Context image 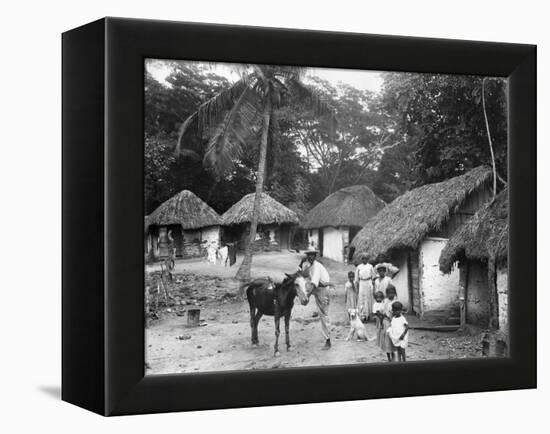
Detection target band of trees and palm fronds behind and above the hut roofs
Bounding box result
[144,61,507,232]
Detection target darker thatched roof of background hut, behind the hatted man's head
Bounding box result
[301,185,385,229]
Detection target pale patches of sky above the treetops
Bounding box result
[146,59,382,92]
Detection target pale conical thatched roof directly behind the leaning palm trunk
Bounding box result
[222,193,298,226]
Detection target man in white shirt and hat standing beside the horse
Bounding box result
[300,250,331,350]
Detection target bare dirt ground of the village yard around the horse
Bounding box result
[145,252,488,375]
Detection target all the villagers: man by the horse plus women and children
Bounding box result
[299,250,409,362]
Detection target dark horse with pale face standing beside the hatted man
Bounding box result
[245,272,308,356]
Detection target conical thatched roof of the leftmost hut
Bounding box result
[149,190,221,230]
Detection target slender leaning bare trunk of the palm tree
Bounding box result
[235,93,272,284]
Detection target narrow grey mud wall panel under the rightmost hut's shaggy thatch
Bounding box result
[466,261,489,327]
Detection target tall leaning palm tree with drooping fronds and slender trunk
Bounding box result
[177,65,336,281]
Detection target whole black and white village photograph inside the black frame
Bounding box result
[143,58,510,375]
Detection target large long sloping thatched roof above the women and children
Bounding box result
[352,166,492,260]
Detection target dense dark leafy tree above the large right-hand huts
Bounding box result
[380,73,507,185]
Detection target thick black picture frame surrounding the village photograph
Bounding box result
[62,18,536,415]
